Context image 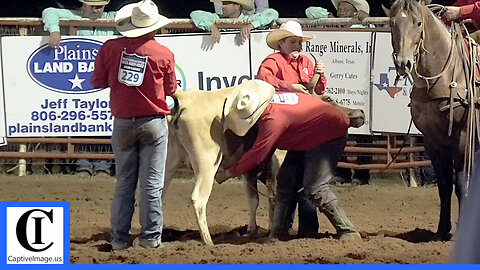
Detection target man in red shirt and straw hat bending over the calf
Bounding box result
[216,89,360,239]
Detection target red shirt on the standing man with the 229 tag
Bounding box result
[90,36,177,118]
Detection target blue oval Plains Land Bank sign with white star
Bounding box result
[27,38,102,94]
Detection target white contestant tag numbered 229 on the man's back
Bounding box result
[118,52,148,86]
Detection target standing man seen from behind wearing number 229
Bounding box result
[91,0,177,250]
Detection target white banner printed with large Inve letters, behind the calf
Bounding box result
[156,33,252,91]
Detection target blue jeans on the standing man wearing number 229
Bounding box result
[110,115,168,249]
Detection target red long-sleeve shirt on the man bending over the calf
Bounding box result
[228,93,350,176]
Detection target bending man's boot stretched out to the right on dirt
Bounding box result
[320,200,362,240]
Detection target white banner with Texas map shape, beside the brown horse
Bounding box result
[371,33,420,134]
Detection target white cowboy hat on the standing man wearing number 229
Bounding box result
[115,0,170,37]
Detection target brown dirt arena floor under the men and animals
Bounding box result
[0,175,457,264]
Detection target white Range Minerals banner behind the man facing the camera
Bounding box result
[251,31,372,134]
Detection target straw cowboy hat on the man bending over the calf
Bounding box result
[223,80,275,136]
